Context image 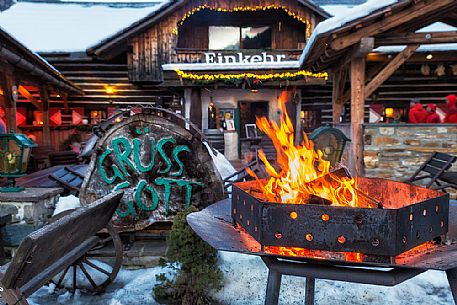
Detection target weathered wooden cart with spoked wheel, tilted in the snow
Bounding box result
[0,192,123,305]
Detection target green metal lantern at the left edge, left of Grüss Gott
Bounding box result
[0,131,37,192]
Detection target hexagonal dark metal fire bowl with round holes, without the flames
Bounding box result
[231,178,449,257]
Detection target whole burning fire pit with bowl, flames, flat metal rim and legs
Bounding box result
[187,101,457,305]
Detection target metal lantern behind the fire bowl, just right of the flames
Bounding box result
[309,125,351,166]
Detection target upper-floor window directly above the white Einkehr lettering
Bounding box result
[209,26,272,50]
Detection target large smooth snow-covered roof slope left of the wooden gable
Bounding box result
[0,0,164,52]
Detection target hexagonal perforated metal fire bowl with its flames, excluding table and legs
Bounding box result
[231,100,449,262]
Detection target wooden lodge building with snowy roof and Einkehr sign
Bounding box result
[0,0,457,178]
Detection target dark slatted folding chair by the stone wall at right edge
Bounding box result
[408,152,457,189]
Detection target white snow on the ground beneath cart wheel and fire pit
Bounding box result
[29,252,453,305]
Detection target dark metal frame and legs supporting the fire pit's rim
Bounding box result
[262,257,430,305]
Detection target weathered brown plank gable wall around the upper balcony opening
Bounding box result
[128,0,319,82]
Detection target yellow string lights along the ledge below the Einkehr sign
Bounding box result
[175,69,328,81]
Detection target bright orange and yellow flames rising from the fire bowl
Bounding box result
[248,92,359,207]
